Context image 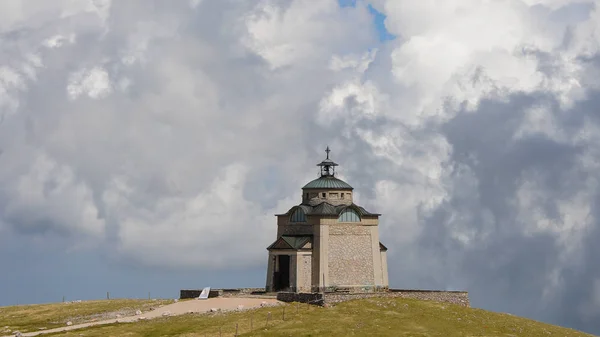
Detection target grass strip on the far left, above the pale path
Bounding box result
[0,299,173,336]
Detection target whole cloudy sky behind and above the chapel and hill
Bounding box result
[0,0,600,334]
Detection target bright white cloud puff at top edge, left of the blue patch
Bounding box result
[244,0,370,69]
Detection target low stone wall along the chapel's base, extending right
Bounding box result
[277,289,471,307]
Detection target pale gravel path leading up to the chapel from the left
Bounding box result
[2,297,282,337]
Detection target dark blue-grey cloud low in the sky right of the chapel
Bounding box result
[432,92,600,333]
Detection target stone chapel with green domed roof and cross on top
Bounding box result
[266,147,389,293]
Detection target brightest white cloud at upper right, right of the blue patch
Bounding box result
[372,0,593,125]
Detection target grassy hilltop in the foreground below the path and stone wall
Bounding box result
[29,298,591,337]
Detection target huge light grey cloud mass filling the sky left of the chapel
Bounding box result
[0,1,375,268]
